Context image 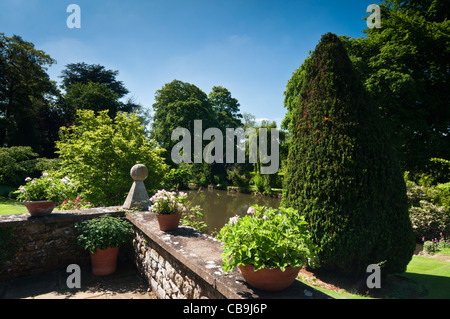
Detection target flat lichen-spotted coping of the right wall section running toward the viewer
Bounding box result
[126,212,329,299]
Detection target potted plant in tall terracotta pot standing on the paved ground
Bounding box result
[75,215,133,276]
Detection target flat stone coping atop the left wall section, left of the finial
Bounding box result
[0,206,125,227]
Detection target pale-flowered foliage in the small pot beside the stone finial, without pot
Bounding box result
[148,189,187,215]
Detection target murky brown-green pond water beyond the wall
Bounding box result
[186,189,281,232]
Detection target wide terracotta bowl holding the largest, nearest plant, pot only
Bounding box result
[238,265,301,291]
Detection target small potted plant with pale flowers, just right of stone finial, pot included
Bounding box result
[148,189,187,231]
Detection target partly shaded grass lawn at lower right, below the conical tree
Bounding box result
[299,255,450,299]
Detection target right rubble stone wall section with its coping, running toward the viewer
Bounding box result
[127,212,327,299]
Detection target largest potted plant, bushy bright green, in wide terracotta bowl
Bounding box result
[218,206,317,291]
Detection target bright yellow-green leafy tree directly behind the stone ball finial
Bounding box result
[57,110,167,205]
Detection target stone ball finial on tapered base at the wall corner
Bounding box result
[123,164,150,210]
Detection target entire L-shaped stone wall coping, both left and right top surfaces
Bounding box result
[0,206,329,299]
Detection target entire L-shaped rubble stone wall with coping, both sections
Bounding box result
[0,207,327,299]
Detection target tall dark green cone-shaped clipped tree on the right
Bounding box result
[282,33,415,276]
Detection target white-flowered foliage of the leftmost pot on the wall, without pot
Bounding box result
[15,173,75,203]
